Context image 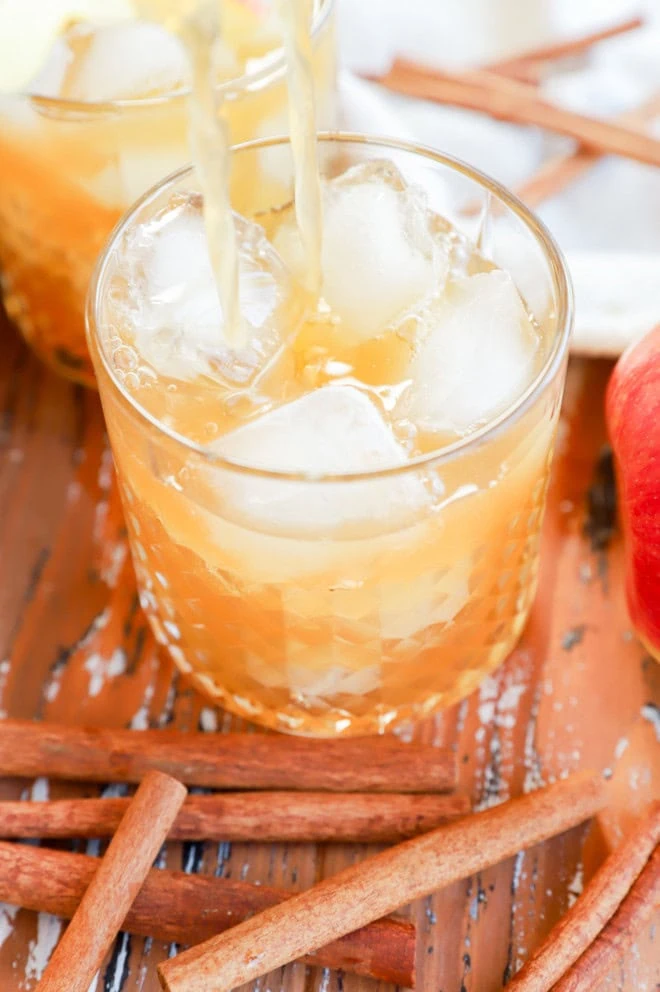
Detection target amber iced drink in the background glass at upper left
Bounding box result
[0,0,335,385]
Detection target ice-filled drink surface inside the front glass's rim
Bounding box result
[106,160,544,456]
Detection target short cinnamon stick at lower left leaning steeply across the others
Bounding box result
[37,772,186,992]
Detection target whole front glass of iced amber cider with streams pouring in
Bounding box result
[90,0,567,735]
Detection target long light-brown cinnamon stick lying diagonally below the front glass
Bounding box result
[158,774,605,992]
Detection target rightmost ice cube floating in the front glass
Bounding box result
[398,270,538,435]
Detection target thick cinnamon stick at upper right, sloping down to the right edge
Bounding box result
[369,59,660,165]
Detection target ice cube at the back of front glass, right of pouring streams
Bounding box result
[275,161,448,344]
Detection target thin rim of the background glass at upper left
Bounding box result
[20,0,336,113]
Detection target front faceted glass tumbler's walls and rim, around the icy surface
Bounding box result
[88,133,572,736]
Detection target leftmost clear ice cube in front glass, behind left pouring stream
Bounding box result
[121,200,299,386]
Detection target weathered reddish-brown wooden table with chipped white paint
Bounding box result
[0,306,660,992]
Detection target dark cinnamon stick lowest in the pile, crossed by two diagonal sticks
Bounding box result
[0,841,415,988]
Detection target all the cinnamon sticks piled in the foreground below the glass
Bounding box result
[0,721,660,992]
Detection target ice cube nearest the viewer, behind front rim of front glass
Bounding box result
[214,385,426,536]
